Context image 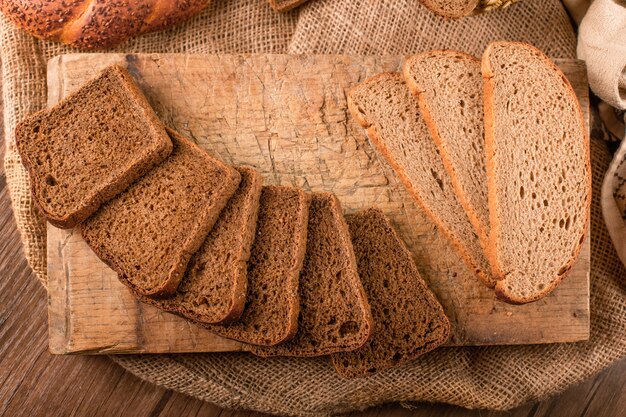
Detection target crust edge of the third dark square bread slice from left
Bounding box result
[128,167,263,324]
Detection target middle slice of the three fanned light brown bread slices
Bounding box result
[403,51,489,248]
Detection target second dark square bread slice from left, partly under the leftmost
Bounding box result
[82,130,240,297]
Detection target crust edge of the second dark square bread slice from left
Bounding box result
[81,128,240,299]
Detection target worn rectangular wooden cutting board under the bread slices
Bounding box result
[48,54,590,354]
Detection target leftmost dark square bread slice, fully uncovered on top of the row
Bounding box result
[15,66,172,228]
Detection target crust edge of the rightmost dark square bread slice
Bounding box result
[331,207,451,378]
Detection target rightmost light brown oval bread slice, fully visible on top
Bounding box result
[482,42,591,303]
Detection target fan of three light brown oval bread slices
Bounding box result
[348,42,591,304]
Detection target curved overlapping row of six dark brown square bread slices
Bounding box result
[16,66,450,377]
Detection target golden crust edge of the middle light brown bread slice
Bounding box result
[402,49,489,251]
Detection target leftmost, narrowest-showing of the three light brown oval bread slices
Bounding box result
[348,73,495,287]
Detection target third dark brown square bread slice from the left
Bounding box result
[139,167,263,324]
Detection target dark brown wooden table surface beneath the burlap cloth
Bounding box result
[0,74,626,417]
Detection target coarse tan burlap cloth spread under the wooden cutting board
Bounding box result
[0,0,626,415]
